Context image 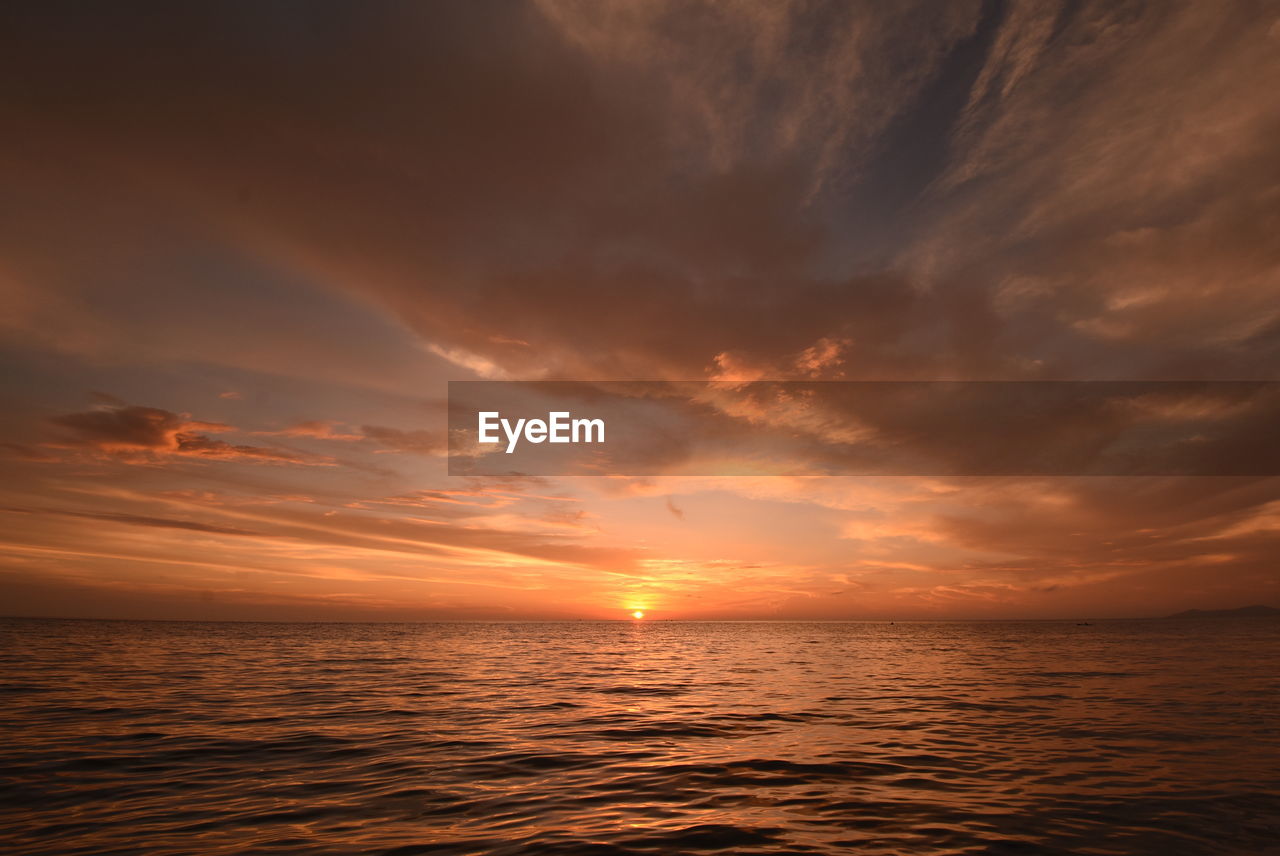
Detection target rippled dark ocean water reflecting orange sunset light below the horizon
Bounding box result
[0,621,1280,855]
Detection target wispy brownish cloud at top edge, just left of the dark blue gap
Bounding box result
[529,0,979,187]
